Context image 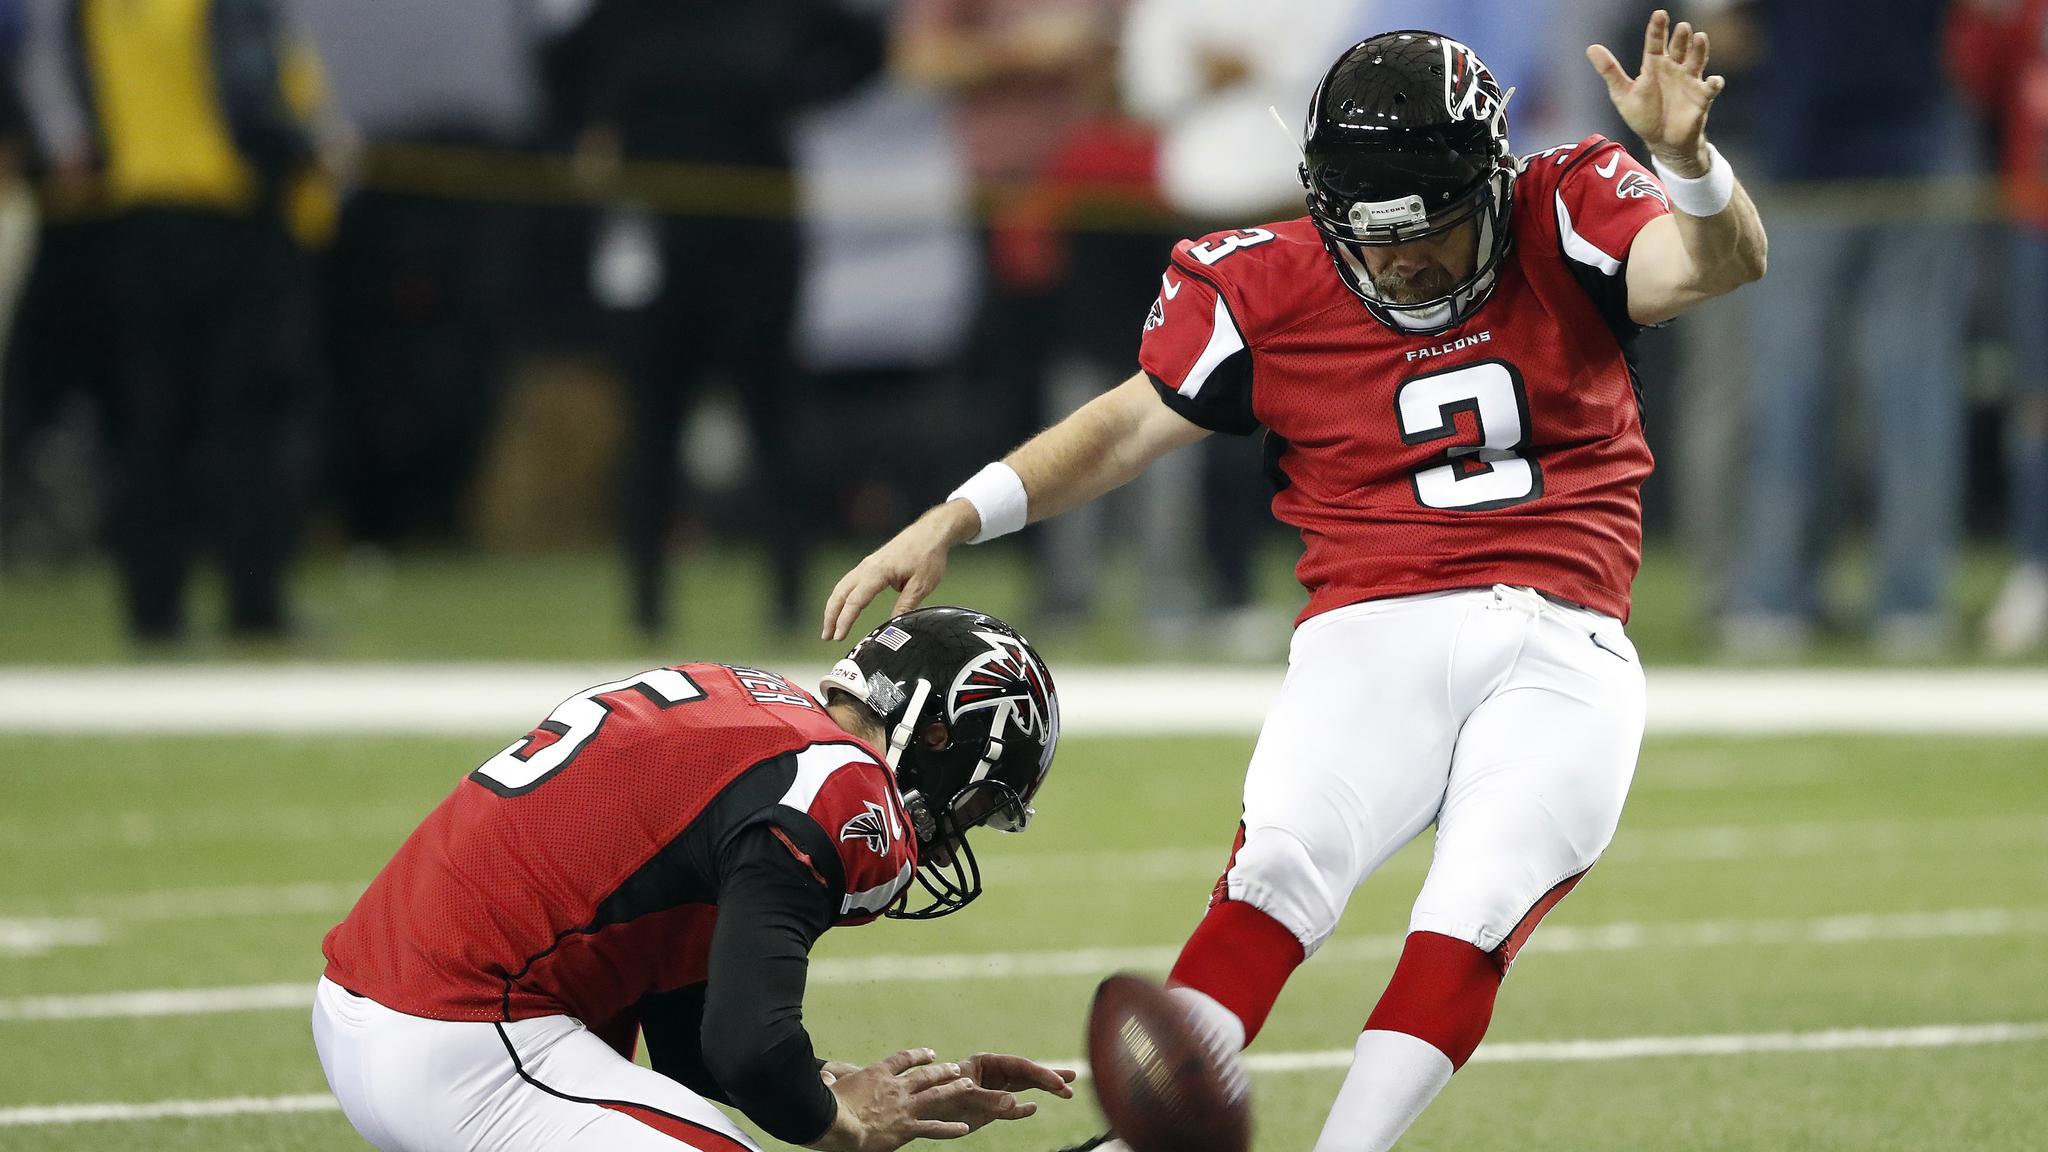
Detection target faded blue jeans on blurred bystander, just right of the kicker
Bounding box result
[1729,215,1970,623]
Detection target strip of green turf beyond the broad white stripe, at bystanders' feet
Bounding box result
[0,535,2048,668]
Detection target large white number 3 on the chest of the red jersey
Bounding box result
[1395,361,1542,512]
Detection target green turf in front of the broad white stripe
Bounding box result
[0,736,2048,1152]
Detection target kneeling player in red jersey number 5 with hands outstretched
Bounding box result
[313,609,1073,1152]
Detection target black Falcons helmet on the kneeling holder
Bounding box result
[819,607,1059,920]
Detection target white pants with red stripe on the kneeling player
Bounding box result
[313,978,760,1152]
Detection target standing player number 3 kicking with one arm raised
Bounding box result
[825,12,1765,1152]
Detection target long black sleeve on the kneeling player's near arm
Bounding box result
[696,824,838,1144]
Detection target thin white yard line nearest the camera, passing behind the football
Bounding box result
[16,1023,2048,1127]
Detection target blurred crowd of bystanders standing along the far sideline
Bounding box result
[0,0,2048,660]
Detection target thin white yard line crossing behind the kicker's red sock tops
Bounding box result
[0,908,2048,1021]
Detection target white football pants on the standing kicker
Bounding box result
[1225,584,1642,955]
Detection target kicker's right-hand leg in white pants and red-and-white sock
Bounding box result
[1317,605,1645,1152]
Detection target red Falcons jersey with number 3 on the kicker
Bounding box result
[1139,135,1669,619]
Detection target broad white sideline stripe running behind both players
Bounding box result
[0,664,2048,738]
